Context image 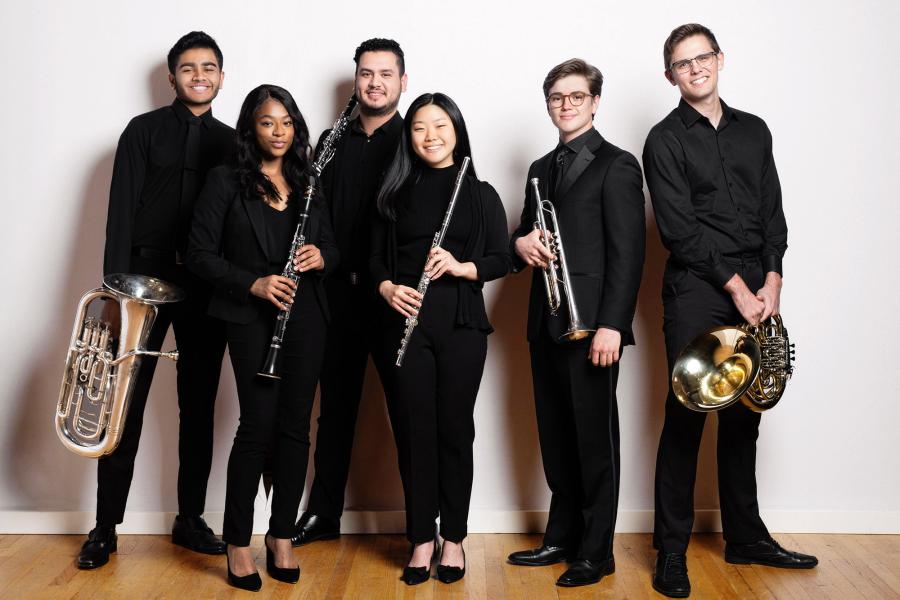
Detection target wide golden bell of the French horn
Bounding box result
[672,327,761,412]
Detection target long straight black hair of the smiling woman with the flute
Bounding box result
[377,92,476,221]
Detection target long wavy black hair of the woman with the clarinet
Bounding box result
[235,84,312,204]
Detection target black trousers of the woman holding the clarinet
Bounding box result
[222,283,326,546]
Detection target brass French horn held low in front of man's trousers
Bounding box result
[672,315,794,412]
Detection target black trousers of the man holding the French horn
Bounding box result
[653,259,769,553]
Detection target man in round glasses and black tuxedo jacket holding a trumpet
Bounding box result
[509,59,644,586]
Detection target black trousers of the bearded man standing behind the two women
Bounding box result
[306,275,379,519]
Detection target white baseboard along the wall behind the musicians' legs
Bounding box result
[0,506,900,535]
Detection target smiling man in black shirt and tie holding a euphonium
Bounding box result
[77,31,234,569]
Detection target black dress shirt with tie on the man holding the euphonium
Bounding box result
[103,100,234,274]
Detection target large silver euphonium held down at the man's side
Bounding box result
[56,274,184,458]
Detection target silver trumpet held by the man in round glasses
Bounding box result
[531,177,596,342]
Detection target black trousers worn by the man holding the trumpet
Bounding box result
[530,330,620,561]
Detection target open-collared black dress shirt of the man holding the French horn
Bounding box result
[644,99,787,287]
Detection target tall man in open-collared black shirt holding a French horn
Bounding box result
[644,23,817,598]
